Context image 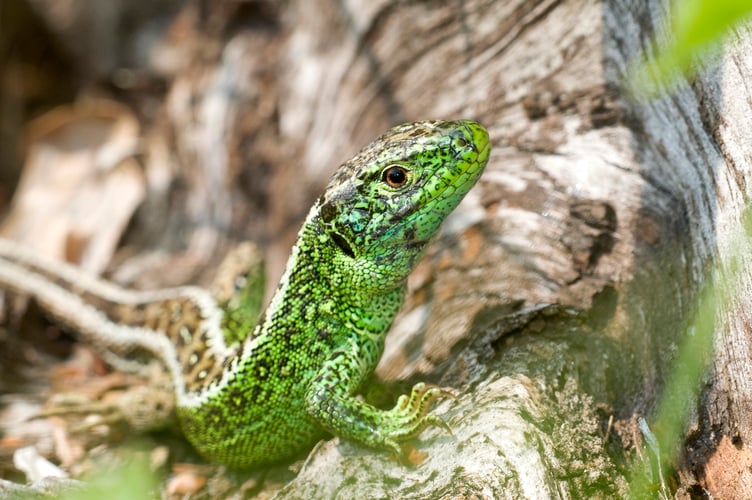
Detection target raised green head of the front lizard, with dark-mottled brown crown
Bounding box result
[319,120,490,290]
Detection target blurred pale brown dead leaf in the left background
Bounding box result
[0,100,145,272]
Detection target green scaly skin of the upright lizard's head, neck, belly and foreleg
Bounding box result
[178,121,490,467]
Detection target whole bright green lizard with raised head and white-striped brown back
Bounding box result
[0,121,490,468]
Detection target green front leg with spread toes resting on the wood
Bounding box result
[305,339,452,456]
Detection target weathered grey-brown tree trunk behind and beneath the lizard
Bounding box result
[1,0,752,498]
